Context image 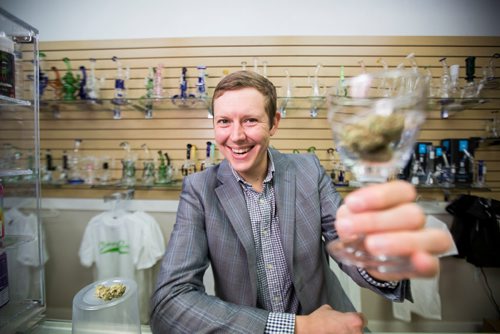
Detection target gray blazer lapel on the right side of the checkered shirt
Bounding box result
[271,150,297,273]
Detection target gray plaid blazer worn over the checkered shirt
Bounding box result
[151,149,409,334]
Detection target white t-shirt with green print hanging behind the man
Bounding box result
[79,211,165,323]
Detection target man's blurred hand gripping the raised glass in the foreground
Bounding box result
[336,181,451,281]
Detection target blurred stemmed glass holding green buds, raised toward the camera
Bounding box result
[328,69,430,272]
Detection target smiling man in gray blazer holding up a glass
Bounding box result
[151,71,450,334]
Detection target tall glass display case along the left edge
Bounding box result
[0,8,46,334]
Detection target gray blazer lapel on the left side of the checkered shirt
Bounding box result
[215,160,257,302]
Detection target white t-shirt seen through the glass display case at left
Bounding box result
[5,208,49,301]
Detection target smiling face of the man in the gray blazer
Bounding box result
[214,88,280,183]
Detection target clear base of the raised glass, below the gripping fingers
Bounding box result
[328,237,413,273]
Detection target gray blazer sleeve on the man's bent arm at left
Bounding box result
[150,173,269,333]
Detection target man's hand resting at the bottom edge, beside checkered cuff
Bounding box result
[295,305,366,334]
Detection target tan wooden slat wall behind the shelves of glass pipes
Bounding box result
[9,36,500,199]
